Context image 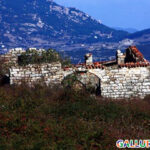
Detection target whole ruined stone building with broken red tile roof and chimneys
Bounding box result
[0,46,150,99]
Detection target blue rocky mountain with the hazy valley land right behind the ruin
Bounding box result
[0,0,149,63]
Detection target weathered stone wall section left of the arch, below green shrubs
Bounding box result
[10,62,64,85]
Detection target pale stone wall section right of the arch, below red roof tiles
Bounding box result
[89,67,150,98]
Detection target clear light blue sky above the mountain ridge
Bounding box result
[54,0,150,30]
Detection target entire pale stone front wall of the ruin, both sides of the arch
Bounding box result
[10,63,150,98]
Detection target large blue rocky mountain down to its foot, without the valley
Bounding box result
[0,0,127,47]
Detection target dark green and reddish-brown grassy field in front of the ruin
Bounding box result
[0,86,150,150]
